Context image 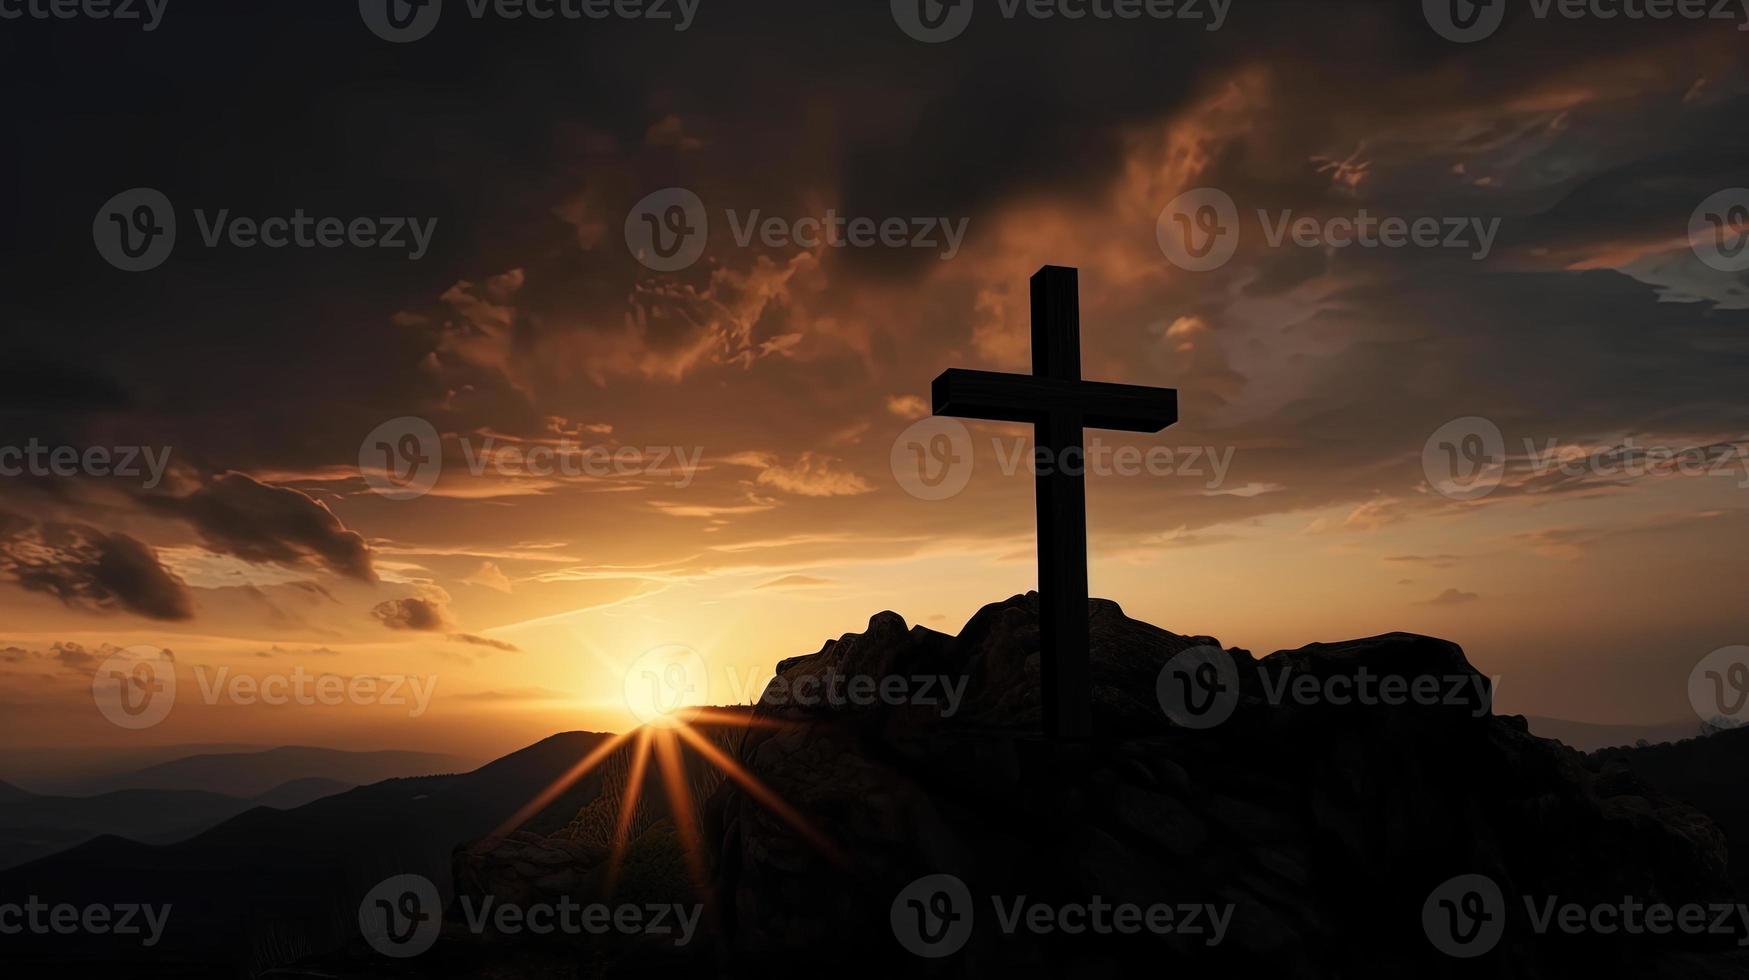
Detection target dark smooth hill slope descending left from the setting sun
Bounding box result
[0,733,607,977]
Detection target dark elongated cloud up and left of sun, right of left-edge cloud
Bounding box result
[145,473,376,583]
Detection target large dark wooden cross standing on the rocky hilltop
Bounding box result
[932,266,1179,739]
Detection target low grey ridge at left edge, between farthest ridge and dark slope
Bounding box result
[0,779,352,868]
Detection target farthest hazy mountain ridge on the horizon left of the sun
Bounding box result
[87,746,474,798]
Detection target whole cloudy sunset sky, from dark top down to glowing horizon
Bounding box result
[0,0,1749,758]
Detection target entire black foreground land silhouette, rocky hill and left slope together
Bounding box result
[0,595,1749,978]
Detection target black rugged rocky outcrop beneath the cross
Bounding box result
[708,595,1742,978]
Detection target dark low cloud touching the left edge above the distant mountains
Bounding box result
[0,511,194,621]
